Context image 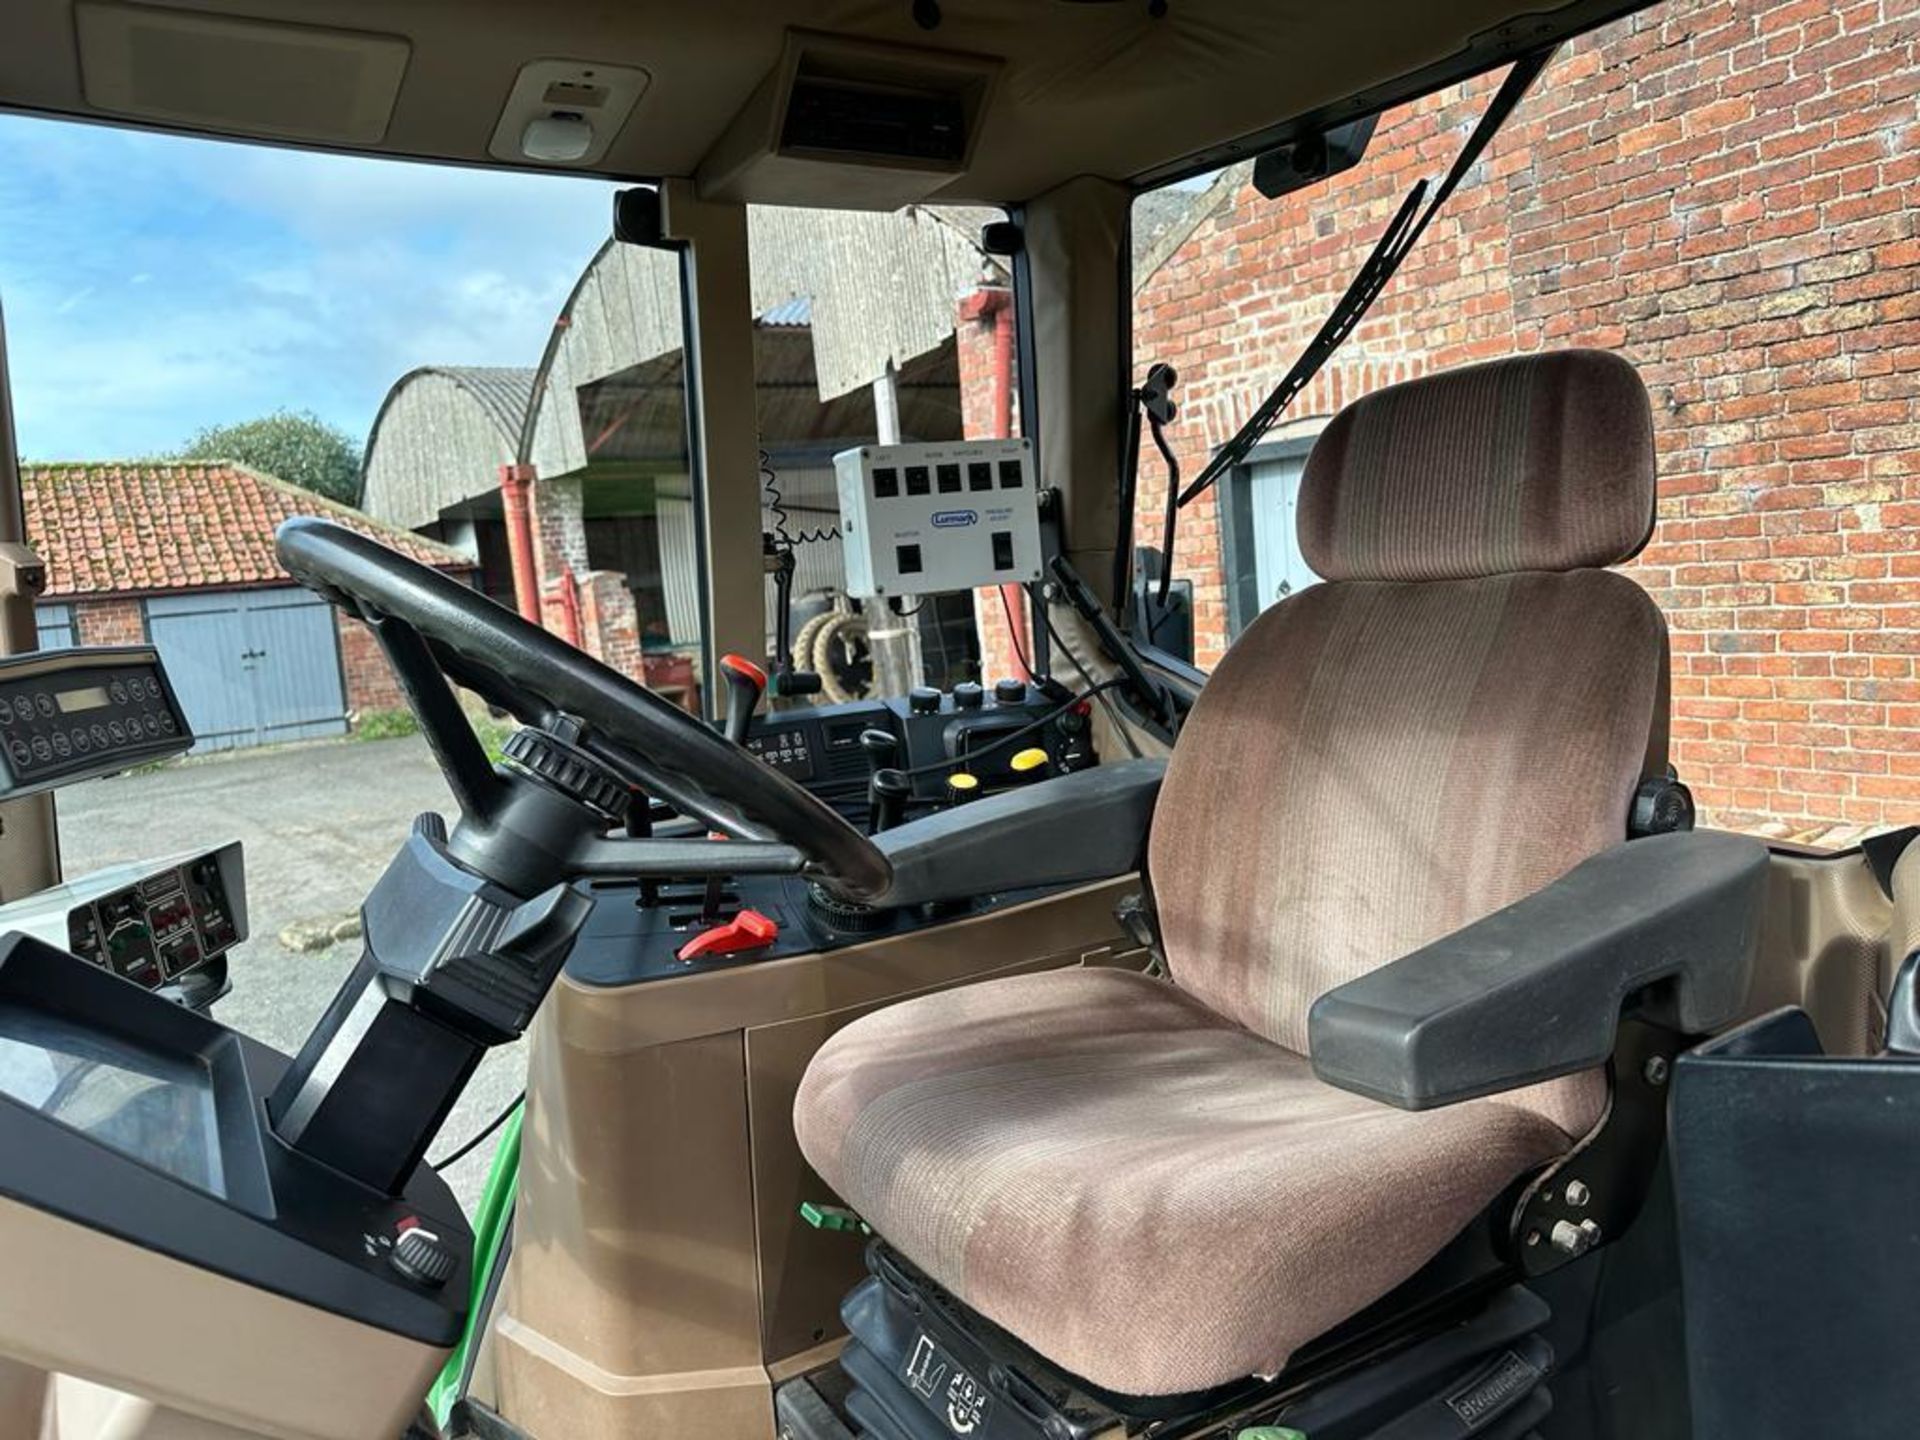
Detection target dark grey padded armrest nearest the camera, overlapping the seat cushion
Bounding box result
[1308,829,1766,1110]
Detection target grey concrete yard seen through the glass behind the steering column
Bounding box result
[58,737,526,1212]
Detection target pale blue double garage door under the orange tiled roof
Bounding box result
[146,588,348,751]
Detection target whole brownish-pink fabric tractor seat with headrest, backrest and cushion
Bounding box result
[795,351,1697,1396]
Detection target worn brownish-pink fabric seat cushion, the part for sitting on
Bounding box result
[795,970,1601,1396]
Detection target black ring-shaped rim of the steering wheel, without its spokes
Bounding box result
[275,516,893,900]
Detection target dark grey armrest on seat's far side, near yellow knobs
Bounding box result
[874,760,1167,904]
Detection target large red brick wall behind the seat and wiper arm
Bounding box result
[1135,0,1920,829]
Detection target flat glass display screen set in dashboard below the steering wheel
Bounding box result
[0,1000,227,1196]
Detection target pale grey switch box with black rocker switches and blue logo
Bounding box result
[833,440,1043,599]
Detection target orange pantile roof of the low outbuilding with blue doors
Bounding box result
[21,461,472,599]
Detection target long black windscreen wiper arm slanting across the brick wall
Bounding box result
[1169,46,1557,510]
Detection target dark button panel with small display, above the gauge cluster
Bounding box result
[0,645,194,799]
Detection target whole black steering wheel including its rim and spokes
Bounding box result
[275,516,893,900]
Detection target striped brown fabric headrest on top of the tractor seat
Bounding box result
[1300,349,1655,580]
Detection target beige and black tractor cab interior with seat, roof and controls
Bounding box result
[0,0,1920,1440]
